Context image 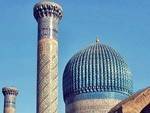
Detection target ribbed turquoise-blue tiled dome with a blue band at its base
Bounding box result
[63,42,132,104]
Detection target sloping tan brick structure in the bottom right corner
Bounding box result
[108,87,150,113]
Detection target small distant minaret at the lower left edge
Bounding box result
[2,87,18,113]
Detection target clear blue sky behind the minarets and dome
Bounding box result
[0,0,150,113]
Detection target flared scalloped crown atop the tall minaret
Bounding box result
[34,0,63,20]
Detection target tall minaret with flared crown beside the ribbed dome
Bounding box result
[34,0,63,113]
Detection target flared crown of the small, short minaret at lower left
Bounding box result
[2,87,18,96]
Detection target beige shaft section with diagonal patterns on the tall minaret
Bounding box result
[37,38,58,113]
